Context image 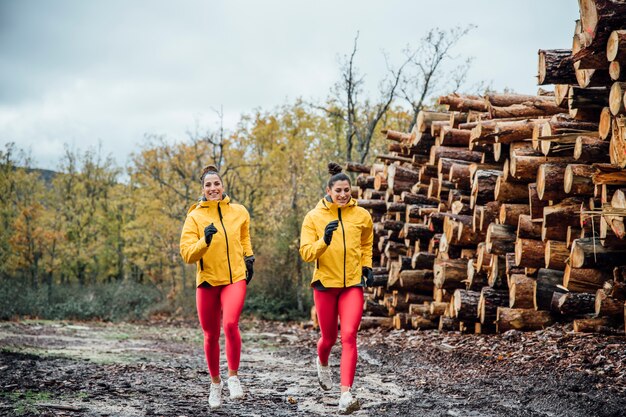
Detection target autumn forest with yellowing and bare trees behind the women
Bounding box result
[0,26,487,320]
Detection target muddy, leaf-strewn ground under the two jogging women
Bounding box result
[0,320,626,417]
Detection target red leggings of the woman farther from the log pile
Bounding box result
[196,280,246,377]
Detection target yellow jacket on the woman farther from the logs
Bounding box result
[180,196,253,286]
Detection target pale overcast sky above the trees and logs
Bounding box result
[0,0,578,169]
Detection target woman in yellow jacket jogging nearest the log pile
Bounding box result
[300,162,374,414]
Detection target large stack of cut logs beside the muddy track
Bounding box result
[347,0,626,333]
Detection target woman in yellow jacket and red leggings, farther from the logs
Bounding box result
[180,165,254,408]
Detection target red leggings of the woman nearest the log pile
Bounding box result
[313,287,363,387]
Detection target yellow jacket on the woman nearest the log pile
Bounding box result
[300,198,374,288]
